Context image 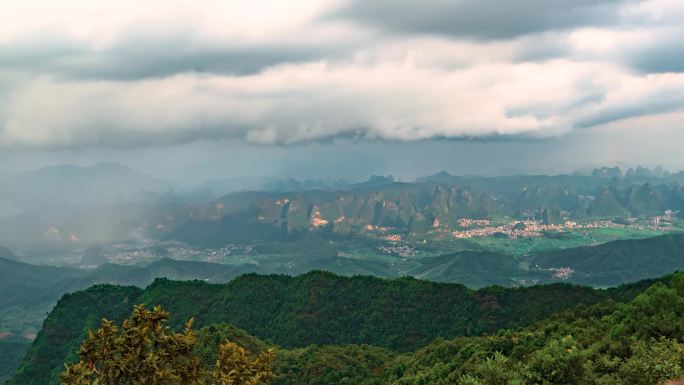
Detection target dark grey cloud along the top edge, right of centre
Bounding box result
[336,0,623,39]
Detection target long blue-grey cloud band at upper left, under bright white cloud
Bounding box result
[0,37,327,80]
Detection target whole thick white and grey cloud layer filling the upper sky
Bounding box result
[0,0,684,148]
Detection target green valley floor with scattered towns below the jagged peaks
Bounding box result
[156,222,683,277]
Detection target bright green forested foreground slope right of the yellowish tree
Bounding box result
[67,273,684,385]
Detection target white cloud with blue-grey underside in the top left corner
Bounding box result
[0,0,364,80]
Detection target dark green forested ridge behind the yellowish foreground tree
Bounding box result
[9,272,670,385]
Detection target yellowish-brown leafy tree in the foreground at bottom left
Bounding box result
[61,305,274,385]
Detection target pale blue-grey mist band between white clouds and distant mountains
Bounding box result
[0,121,684,185]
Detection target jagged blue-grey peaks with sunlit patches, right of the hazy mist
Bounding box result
[164,177,684,244]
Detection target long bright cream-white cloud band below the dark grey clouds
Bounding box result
[5,60,684,147]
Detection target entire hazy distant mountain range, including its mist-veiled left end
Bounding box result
[0,163,684,249]
